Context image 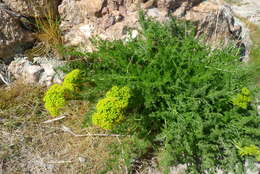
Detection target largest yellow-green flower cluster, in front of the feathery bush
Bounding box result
[92,86,131,130]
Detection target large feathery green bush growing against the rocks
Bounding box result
[64,11,260,173]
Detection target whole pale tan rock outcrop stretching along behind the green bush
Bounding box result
[59,0,249,59]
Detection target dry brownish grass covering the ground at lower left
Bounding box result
[0,83,117,174]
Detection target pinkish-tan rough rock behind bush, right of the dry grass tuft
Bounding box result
[59,0,173,51]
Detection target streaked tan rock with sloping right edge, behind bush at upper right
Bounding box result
[183,0,251,61]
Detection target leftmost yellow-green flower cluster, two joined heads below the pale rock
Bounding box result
[43,69,80,116]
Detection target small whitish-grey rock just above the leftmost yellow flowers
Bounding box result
[8,57,65,86]
